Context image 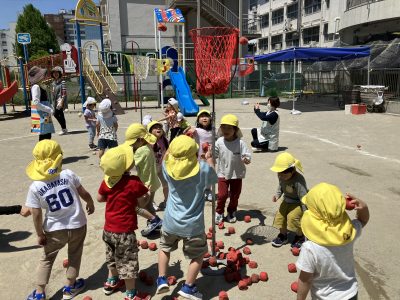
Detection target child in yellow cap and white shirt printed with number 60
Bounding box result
[26,140,94,300]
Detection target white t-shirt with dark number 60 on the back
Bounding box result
[25,169,87,232]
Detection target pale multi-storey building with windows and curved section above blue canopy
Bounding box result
[249,0,400,54]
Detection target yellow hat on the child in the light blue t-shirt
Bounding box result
[165,135,200,180]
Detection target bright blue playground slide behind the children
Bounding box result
[168,67,199,116]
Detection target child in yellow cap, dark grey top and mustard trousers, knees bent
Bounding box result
[271,152,307,248]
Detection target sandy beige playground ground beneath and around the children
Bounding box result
[0,98,400,300]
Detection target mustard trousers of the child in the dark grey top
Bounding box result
[273,201,303,235]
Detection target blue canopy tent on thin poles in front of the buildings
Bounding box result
[254,46,371,114]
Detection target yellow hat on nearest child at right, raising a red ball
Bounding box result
[301,182,356,246]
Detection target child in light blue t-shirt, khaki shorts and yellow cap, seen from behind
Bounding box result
[157,135,217,300]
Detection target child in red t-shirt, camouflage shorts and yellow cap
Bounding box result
[97,145,148,300]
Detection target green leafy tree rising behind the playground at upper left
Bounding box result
[15,4,60,58]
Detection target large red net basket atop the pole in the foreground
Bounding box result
[190,27,239,96]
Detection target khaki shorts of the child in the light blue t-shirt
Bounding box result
[160,229,208,259]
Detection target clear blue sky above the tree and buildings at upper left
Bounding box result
[0,0,99,29]
